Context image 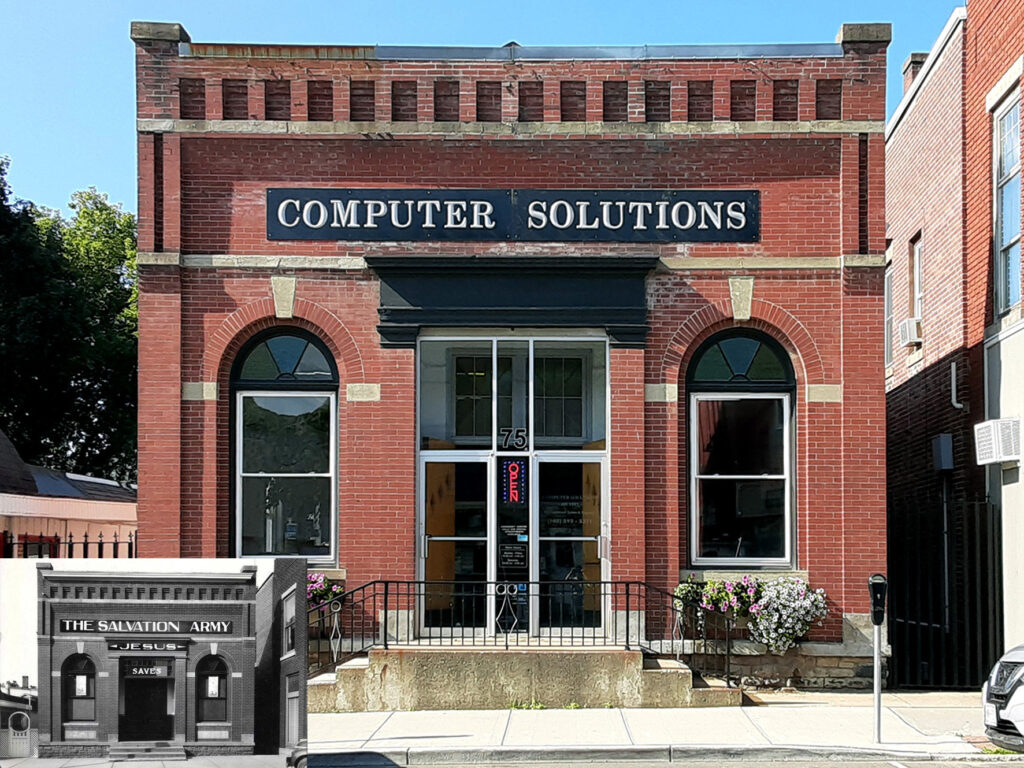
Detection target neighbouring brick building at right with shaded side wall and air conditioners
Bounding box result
[886,0,1024,688]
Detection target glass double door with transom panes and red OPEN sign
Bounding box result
[420,339,606,634]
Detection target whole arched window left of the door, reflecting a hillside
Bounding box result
[231,328,338,561]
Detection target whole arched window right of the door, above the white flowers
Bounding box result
[686,329,796,566]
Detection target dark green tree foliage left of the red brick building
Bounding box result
[0,158,138,479]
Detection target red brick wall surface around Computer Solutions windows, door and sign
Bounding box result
[133,25,888,640]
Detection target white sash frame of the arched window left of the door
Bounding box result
[234,387,338,564]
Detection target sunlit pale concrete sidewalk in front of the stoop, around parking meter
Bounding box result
[309,692,999,765]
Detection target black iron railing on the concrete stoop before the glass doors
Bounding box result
[308,581,734,681]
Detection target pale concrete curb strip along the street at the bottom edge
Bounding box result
[309,744,995,768]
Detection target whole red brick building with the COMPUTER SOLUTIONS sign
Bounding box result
[132,23,890,671]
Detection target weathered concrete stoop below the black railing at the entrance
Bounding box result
[307,648,742,713]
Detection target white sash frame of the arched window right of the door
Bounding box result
[688,390,795,567]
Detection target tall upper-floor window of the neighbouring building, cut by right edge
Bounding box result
[993,95,1021,312]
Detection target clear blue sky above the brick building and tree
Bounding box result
[0,0,963,217]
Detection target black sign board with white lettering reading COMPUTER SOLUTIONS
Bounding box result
[266,188,761,243]
